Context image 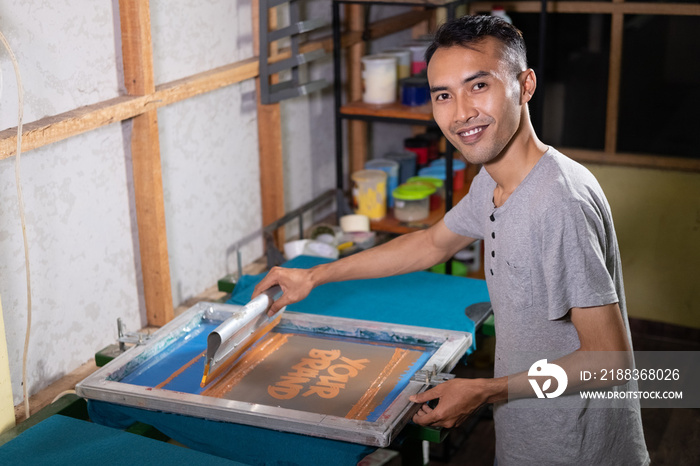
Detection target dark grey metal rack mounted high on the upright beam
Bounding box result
[259,0,328,104]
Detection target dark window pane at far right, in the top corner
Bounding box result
[617,15,700,158]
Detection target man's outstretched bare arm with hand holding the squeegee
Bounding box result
[253,220,474,315]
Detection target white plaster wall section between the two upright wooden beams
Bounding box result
[151,0,262,305]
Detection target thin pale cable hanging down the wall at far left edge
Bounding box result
[0,27,32,418]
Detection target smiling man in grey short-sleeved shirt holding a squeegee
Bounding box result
[254,16,649,465]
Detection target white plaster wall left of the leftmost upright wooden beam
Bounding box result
[0,0,132,403]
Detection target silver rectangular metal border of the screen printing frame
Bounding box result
[76,302,472,447]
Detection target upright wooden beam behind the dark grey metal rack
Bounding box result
[251,0,285,249]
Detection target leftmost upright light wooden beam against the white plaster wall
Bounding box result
[119,0,174,326]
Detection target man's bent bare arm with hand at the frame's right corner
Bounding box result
[411,303,630,427]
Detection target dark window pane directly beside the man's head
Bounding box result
[509,13,610,150]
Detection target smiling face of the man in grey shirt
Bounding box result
[428,37,522,164]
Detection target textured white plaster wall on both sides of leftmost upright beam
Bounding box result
[0,0,266,403]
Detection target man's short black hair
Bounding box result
[425,15,527,73]
